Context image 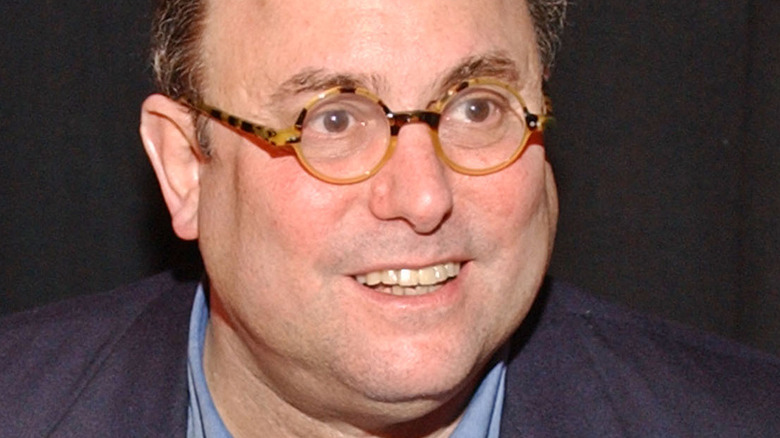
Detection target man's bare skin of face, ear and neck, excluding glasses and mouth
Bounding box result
[141,0,557,437]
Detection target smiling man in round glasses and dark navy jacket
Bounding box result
[0,0,780,437]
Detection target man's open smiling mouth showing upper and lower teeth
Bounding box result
[355,262,460,296]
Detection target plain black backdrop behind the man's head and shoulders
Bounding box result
[0,0,780,353]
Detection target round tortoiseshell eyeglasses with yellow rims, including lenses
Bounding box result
[185,78,552,184]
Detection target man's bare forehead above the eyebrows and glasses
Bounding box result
[203,0,541,105]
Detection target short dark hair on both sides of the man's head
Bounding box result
[152,0,568,100]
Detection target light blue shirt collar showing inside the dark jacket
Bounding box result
[187,285,506,438]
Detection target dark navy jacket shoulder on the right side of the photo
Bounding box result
[505,281,780,436]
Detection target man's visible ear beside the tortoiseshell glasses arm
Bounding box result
[140,94,204,240]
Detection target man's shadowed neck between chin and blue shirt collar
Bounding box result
[203,312,478,438]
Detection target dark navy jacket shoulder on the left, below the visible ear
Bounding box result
[0,273,195,436]
